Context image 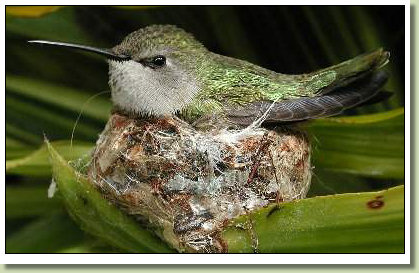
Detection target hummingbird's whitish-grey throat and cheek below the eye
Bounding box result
[109,60,199,116]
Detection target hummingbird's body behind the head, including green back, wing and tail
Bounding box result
[185,49,389,123]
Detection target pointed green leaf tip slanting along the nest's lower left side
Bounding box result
[47,142,173,253]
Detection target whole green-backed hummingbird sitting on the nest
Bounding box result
[29,25,390,125]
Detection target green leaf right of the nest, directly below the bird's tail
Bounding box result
[308,108,404,179]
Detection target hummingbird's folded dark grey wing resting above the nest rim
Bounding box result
[227,71,388,125]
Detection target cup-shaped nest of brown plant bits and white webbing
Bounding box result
[88,113,311,253]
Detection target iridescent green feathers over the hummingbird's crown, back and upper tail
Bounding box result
[113,25,389,122]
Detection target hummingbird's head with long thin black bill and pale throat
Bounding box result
[31,25,207,116]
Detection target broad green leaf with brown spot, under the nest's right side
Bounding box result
[222,186,404,253]
